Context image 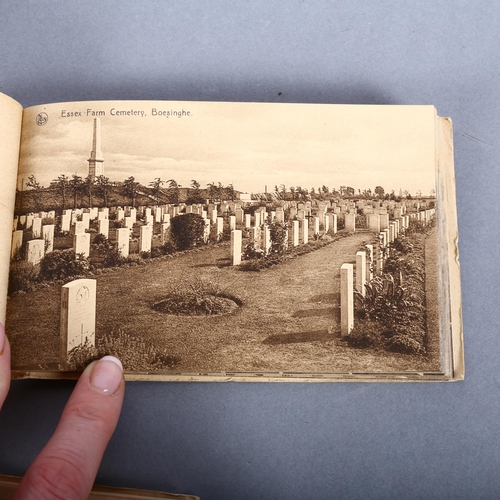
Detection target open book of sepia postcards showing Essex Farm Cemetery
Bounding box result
[0,96,464,381]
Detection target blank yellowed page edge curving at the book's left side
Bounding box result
[0,94,23,323]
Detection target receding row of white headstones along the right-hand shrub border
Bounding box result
[340,209,436,336]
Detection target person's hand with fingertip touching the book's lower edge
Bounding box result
[0,322,125,500]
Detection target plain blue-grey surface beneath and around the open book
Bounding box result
[0,0,494,500]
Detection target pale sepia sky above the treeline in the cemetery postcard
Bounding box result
[19,101,435,195]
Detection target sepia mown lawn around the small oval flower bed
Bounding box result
[7,232,440,373]
